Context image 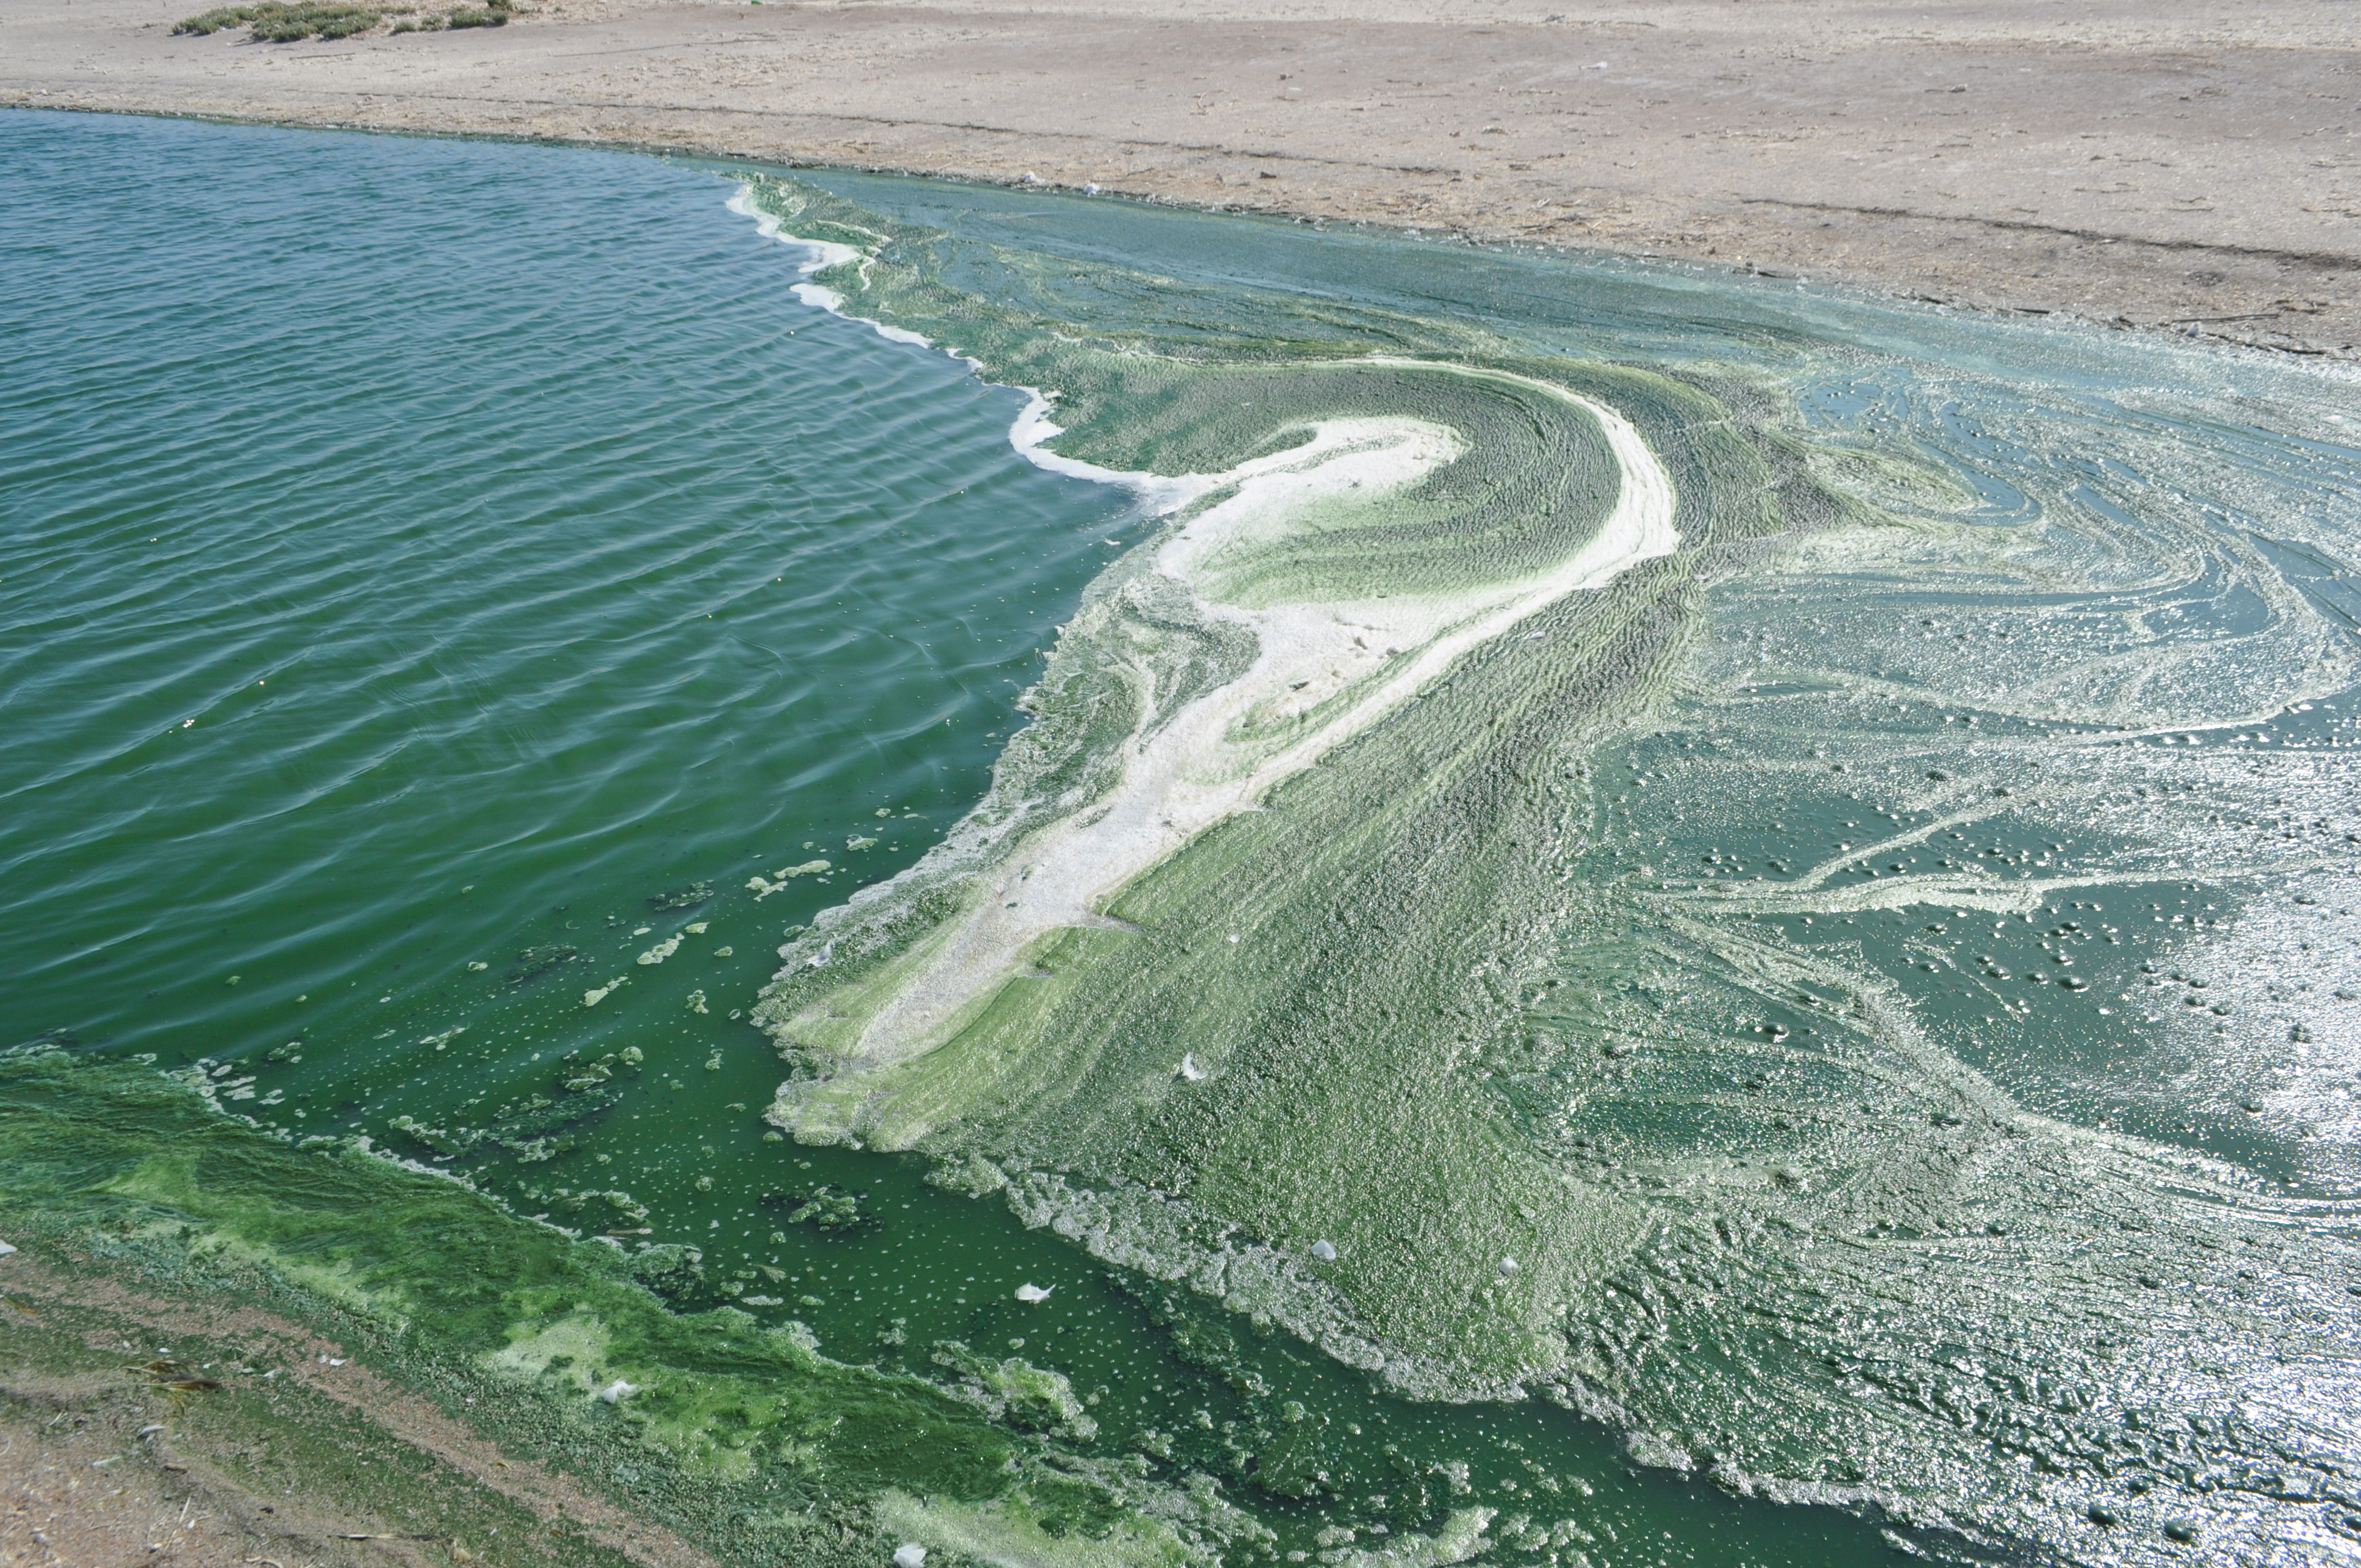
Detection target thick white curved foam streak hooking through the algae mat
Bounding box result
[807,359,1679,1114]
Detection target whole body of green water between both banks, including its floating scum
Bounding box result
[0,113,2361,1563]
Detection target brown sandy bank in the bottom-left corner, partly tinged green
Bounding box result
[0,1254,711,1568]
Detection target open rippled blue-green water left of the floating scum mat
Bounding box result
[0,116,1898,1561]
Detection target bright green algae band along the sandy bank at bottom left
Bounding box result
[0,1048,1261,1566]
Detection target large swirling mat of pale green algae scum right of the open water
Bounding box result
[751,168,2361,1561]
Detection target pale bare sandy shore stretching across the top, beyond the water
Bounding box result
[0,0,2361,354]
